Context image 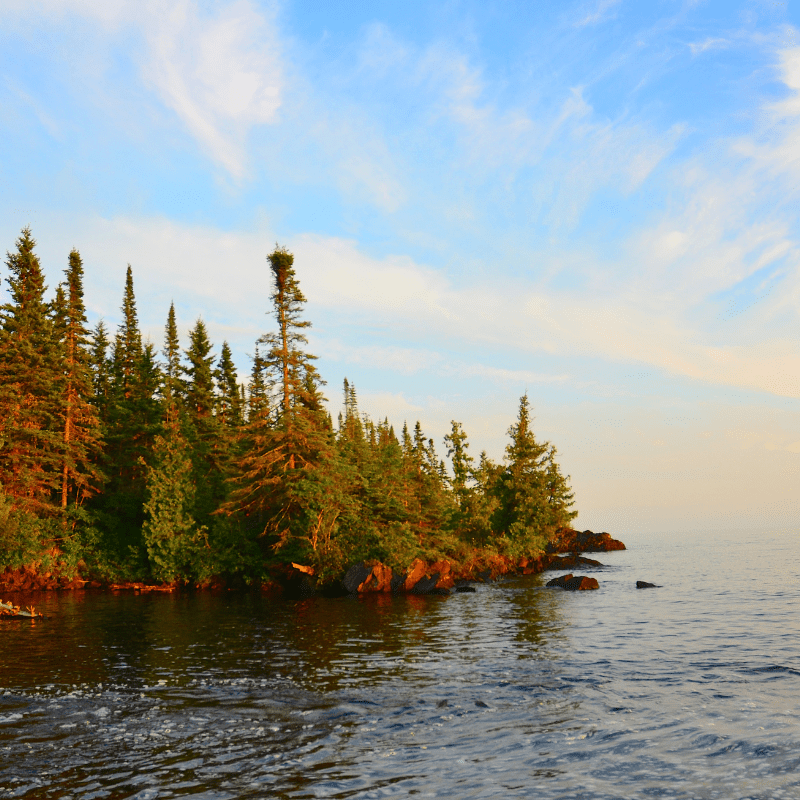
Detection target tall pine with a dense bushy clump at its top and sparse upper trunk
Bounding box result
[223,247,352,563]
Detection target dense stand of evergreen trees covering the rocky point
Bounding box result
[0,228,577,585]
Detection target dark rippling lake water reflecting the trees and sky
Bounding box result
[0,532,800,800]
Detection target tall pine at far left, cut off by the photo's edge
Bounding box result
[0,228,63,514]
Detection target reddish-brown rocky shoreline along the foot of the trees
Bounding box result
[0,528,625,597]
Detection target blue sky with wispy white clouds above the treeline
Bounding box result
[0,0,800,538]
